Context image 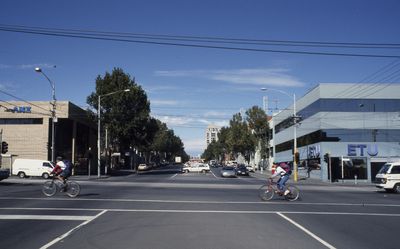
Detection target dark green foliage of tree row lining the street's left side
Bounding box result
[87,68,188,161]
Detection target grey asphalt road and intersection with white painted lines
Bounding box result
[0,165,400,249]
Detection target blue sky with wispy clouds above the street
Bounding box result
[0,0,400,155]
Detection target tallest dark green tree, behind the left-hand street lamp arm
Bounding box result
[87,68,155,154]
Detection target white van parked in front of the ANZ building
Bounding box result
[12,158,54,179]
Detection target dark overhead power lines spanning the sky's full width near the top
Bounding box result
[0,24,400,58]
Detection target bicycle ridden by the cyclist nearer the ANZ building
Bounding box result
[42,176,81,197]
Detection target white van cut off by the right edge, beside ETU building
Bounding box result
[375,162,400,193]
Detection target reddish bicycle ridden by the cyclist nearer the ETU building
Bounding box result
[258,179,300,201]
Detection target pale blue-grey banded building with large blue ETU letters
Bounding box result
[270,83,400,182]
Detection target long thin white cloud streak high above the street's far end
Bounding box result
[155,68,304,87]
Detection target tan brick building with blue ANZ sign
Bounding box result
[0,101,97,168]
